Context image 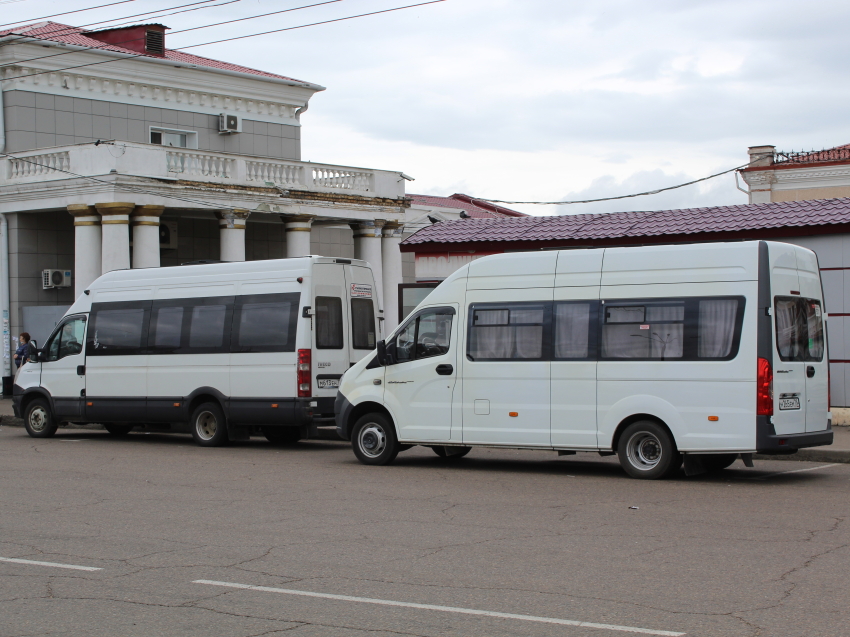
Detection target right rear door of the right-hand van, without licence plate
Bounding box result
[797,249,829,431]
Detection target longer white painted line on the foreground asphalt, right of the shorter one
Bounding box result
[192,579,686,637]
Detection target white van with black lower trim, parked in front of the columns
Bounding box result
[13,256,380,446]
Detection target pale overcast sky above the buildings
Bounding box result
[6,0,850,214]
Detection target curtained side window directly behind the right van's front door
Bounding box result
[467,303,549,361]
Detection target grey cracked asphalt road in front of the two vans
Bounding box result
[0,427,850,637]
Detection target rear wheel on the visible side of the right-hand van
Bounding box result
[617,420,682,480]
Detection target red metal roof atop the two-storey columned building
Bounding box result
[0,22,311,85]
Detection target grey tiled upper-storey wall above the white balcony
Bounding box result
[3,91,301,160]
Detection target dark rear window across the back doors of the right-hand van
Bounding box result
[774,296,824,362]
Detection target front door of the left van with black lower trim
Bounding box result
[39,316,86,421]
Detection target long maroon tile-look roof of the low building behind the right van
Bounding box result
[402,198,850,251]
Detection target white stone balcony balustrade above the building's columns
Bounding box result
[0,142,404,199]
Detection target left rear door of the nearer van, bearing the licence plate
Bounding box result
[769,243,806,435]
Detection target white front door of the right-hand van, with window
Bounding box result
[384,304,458,441]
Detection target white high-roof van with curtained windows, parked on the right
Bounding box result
[335,241,833,478]
